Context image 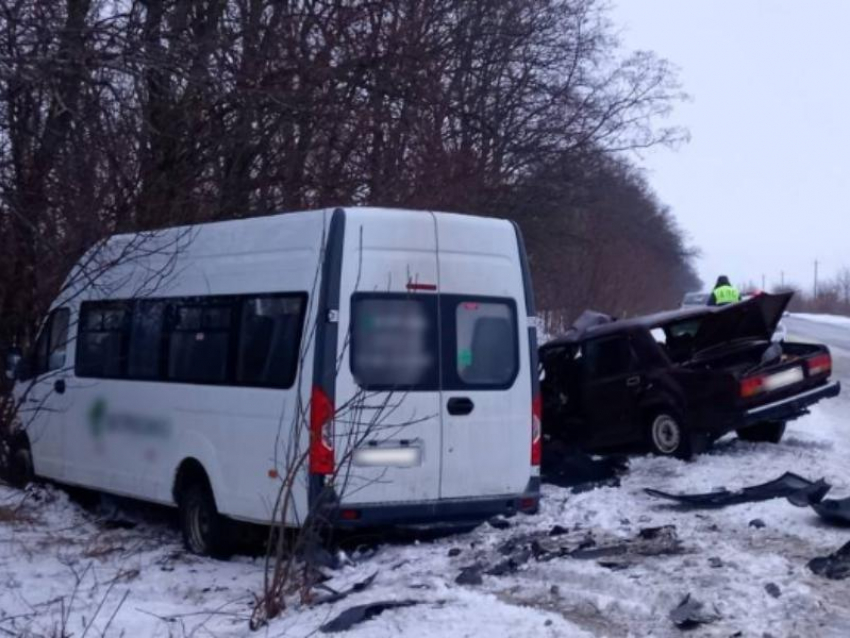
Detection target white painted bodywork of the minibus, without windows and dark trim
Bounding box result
[17,208,534,525]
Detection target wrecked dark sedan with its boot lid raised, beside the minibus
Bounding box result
[540,294,841,458]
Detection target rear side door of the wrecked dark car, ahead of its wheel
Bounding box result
[582,335,641,447]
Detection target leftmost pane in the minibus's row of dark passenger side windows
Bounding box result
[76,301,130,379]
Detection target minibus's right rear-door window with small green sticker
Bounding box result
[450,296,519,389]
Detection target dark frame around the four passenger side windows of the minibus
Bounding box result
[74,291,309,390]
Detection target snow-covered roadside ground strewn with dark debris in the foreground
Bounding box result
[0,398,850,638]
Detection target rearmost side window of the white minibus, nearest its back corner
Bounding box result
[236,295,306,388]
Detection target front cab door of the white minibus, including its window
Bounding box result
[17,308,71,479]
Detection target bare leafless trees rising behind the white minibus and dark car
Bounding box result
[0,0,697,350]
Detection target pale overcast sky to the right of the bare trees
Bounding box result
[612,0,850,291]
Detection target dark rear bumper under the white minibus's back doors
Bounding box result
[328,478,540,529]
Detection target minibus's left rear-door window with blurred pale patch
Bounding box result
[351,294,439,391]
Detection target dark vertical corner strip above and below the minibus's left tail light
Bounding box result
[309,208,345,512]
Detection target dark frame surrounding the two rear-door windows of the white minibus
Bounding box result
[348,292,522,393]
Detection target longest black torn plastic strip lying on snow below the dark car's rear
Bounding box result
[644,472,829,509]
